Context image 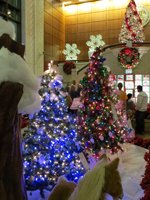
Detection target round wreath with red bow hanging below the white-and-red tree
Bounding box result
[118,47,140,69]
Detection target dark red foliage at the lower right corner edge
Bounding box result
[141,150,150,200]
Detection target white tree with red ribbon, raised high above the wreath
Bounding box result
[119,0,144,43]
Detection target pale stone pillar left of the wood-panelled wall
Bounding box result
[22,0,44,75]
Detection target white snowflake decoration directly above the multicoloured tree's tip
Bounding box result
[86,34,105,51]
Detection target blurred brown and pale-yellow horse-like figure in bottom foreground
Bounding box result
[48,158,123,200]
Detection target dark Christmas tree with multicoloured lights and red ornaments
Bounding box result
[78,49,131,158]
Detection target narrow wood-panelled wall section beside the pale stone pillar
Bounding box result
[44,0,65,69]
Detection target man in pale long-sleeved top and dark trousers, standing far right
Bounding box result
[136,85,148,134]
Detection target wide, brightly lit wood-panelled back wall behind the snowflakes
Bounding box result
[65,0,150,60]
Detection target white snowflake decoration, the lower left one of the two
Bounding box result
[63,43,80,60]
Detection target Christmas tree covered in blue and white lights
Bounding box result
[23,72,85,194]
